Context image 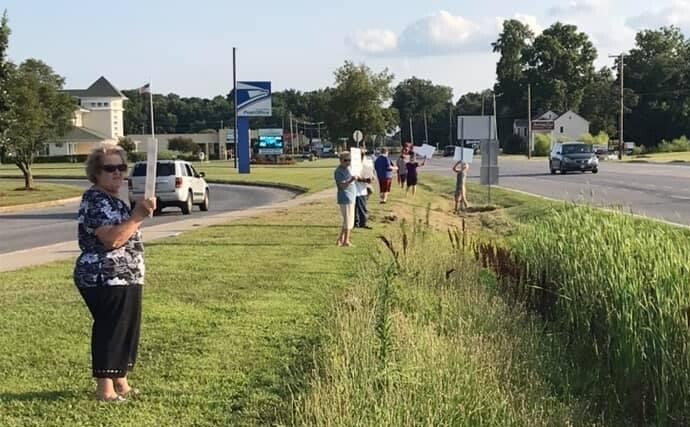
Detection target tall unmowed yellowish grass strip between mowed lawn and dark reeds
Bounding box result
[289,221,591,426]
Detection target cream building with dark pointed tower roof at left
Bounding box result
[45,77,127,156]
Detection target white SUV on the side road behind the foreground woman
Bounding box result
[128,160,209,215]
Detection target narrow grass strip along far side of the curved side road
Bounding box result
[0,159,337,191]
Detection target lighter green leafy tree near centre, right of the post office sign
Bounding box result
[328,61,397,144]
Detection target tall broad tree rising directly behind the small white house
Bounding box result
[525,22,597,112]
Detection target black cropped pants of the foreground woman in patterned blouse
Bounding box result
[79,285,142,378]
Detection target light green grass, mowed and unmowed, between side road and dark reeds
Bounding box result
[0,178,612,427]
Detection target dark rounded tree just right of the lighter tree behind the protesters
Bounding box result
[392,77,453,144]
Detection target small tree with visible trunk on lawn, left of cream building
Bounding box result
[6,59,77,190]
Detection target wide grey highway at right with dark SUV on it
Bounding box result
[420,157,690,225]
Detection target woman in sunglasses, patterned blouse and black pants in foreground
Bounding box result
[74,145,156,402]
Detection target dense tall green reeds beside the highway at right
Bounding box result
[486,205,690,425]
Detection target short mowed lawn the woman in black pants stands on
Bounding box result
[0,200,375,427]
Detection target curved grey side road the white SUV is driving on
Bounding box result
[0,180,295,256]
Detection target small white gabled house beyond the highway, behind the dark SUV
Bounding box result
[513,111,589,142]
